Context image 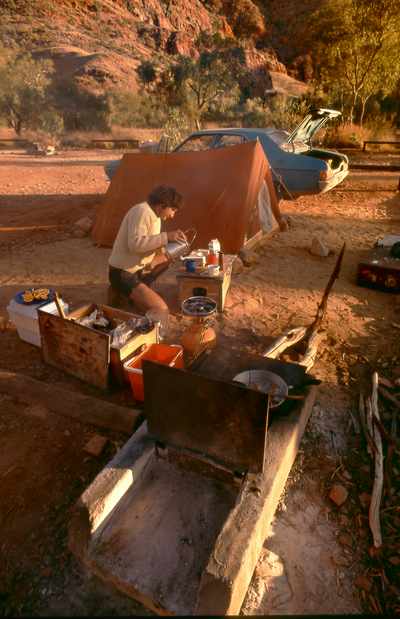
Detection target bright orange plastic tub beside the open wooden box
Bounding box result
[124,344,183,402]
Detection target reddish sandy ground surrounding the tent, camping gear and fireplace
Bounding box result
[0,151,400,615]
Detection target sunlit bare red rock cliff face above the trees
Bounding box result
[0,0,292,97]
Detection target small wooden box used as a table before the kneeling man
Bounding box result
[176,254,236,312]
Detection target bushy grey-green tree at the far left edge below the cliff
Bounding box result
[0,50,62,135]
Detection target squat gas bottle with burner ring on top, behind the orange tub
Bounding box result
[181,296,217,360]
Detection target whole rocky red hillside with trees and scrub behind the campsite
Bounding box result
[0,0,400,137]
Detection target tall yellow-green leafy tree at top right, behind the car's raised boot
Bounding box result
[317,0,400,123]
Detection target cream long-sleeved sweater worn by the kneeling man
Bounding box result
[108,202,168,273]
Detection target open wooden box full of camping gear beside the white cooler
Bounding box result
[38,303,158,389]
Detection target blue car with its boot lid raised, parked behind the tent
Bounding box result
[175,108,349,200]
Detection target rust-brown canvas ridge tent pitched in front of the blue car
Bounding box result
[92,141,277,253]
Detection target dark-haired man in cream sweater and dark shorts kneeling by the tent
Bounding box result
[108,185,186,312]
